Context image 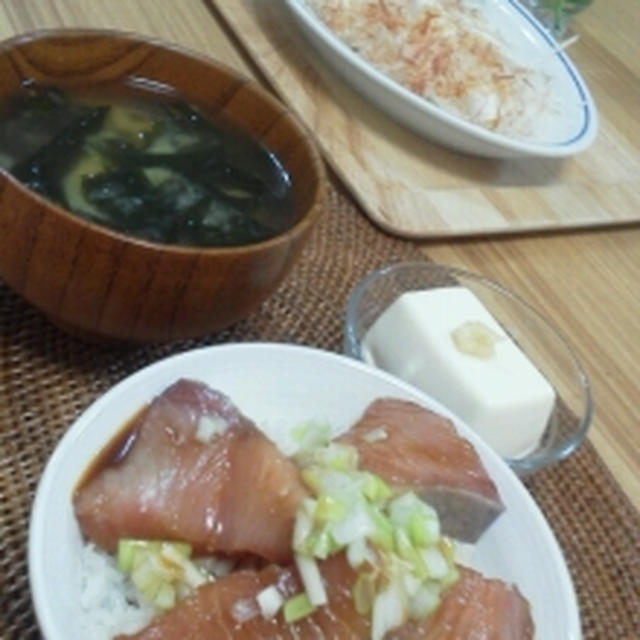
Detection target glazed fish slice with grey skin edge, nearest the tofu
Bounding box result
[339,398,504,542]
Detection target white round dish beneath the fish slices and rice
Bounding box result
[29,344,581,640]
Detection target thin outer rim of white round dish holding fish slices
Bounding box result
[27,341,582,640]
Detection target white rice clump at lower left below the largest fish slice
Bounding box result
[80,544,154,640]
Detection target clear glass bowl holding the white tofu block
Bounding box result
[344,262,593,477]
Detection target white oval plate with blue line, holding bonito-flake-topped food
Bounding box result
[285,0,598,158]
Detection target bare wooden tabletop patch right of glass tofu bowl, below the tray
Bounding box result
[423,229,640,509]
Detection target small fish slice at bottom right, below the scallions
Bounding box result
[386,568,534,640]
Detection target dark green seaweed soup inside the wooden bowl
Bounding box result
[0,86,294,246]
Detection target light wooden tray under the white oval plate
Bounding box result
[212,0,640,238]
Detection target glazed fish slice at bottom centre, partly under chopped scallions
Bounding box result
[116,555,370,640]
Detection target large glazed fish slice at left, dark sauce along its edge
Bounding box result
[73,380,305,563]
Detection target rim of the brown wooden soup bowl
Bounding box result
[0,27,327,256]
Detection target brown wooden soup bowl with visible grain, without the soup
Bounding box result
[0,30,326,342]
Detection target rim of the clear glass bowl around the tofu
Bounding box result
[343,261,594,477]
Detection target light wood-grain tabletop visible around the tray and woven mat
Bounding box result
[0,0,640,509]
